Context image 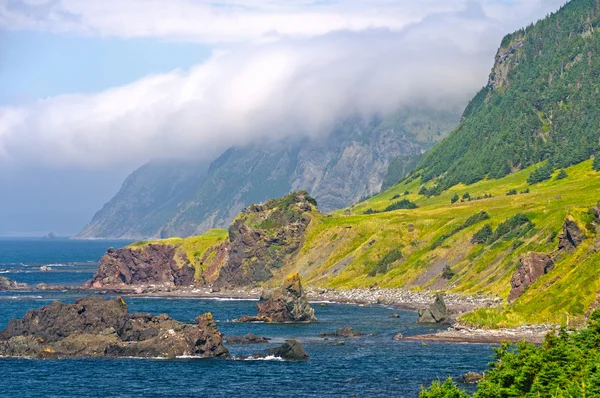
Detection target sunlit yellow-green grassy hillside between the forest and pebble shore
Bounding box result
[124,160,600,327]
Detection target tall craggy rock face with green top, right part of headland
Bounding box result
[215,191,316,287]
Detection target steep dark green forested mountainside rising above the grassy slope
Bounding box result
[415,0,600,192]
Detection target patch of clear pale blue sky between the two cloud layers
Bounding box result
[0,30,211,105]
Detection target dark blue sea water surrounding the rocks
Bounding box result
[0,241,493,398]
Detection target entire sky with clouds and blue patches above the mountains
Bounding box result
[0,0,564,236]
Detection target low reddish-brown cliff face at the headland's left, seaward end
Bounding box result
[86,244,195,288]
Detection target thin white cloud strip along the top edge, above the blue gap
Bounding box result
[0,0,564,42]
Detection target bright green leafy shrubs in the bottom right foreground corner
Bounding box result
[419,310,600,398]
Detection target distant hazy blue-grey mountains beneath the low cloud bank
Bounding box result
[77,109,459,239]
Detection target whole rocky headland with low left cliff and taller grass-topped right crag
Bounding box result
[86,191,317,289]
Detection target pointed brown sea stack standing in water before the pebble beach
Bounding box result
[238,274,317,323]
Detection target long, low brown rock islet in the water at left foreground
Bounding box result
[0,297,229,358]
